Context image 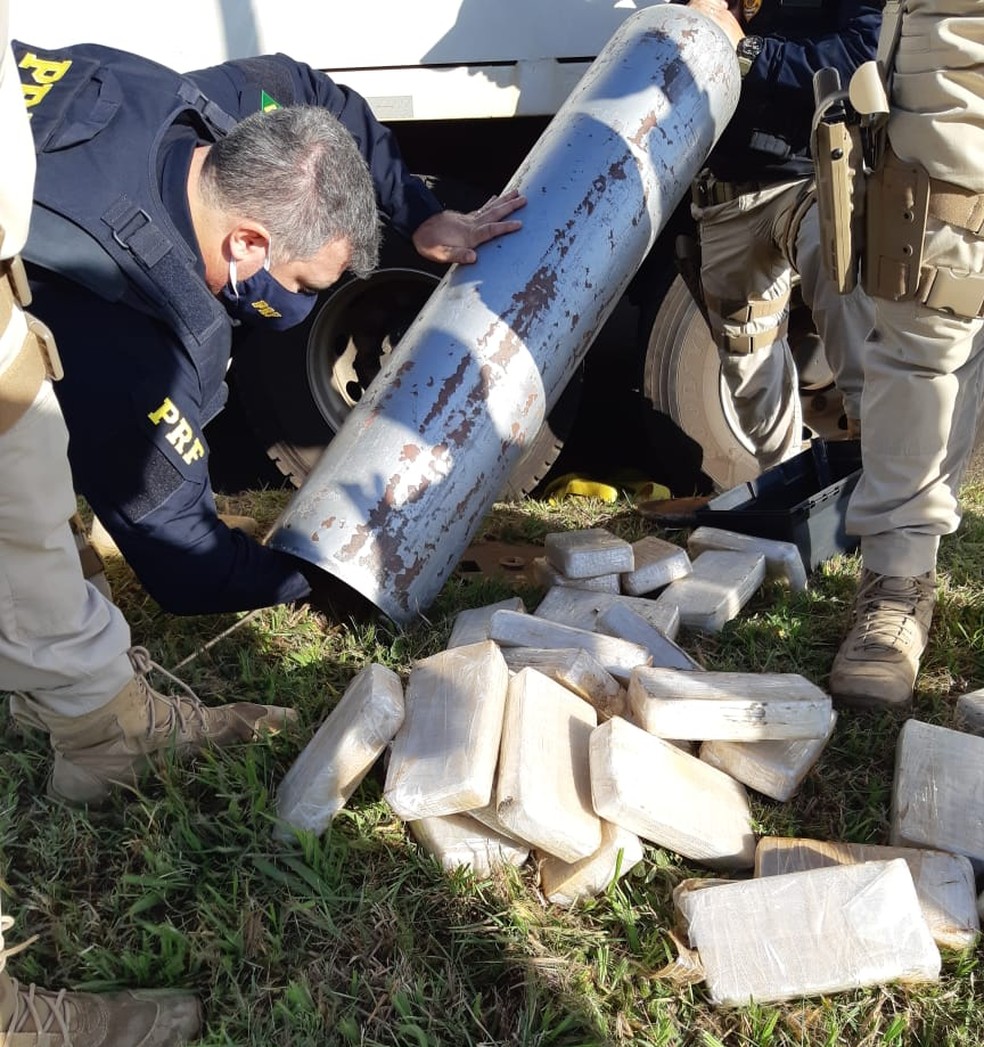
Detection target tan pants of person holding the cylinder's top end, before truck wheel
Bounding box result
[693,180,874,468]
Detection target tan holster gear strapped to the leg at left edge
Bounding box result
[0,229,63,432]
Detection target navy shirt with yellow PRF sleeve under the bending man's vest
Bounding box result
[21,45,441,615]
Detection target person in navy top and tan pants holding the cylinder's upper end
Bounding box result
[689,0,881,468]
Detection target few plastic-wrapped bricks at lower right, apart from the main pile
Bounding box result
[674,707,984,1005]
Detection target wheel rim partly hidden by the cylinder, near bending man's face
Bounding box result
[307,269,440,432]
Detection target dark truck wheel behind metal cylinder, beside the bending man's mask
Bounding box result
[228,260,580,500]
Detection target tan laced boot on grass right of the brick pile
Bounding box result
[829,569,936,708]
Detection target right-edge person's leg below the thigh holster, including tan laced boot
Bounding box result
[830,220,984,706]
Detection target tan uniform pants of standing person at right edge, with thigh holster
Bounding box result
[847,0,984,576]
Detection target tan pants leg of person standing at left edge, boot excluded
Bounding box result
[0,307,133,716]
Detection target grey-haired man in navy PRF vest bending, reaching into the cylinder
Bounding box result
[15,43,524,614]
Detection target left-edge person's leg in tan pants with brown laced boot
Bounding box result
[0,273,289,803]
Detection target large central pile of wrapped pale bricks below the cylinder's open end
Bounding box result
[278,529,832,903]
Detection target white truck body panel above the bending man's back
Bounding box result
[10,0,664,120]
